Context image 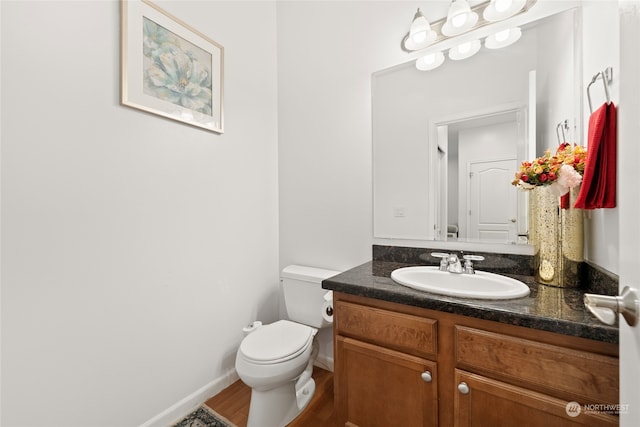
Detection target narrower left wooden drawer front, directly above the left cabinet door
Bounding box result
[334,301,438,358]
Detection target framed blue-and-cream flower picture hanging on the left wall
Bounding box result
[121,0,224,133]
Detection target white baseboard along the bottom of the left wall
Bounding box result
[140,369,239,427]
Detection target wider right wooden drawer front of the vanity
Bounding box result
[455,326,618,404]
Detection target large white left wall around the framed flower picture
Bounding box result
[0,1,279,427]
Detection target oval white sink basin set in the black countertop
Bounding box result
[391,266,529,299]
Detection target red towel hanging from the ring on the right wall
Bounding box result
[574,102,618,209]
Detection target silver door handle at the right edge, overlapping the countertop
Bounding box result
[584,286,640,326]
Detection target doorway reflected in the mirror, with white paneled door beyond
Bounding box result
[435,111,526,243]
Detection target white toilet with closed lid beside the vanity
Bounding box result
[236,265,339,427]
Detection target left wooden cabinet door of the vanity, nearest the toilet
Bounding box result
[334,336,438,427]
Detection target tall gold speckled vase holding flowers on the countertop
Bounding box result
[529,186,584,287]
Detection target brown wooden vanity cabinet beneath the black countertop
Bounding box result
[334,292,619,427]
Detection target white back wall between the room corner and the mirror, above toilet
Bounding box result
[277,1,419,374]
